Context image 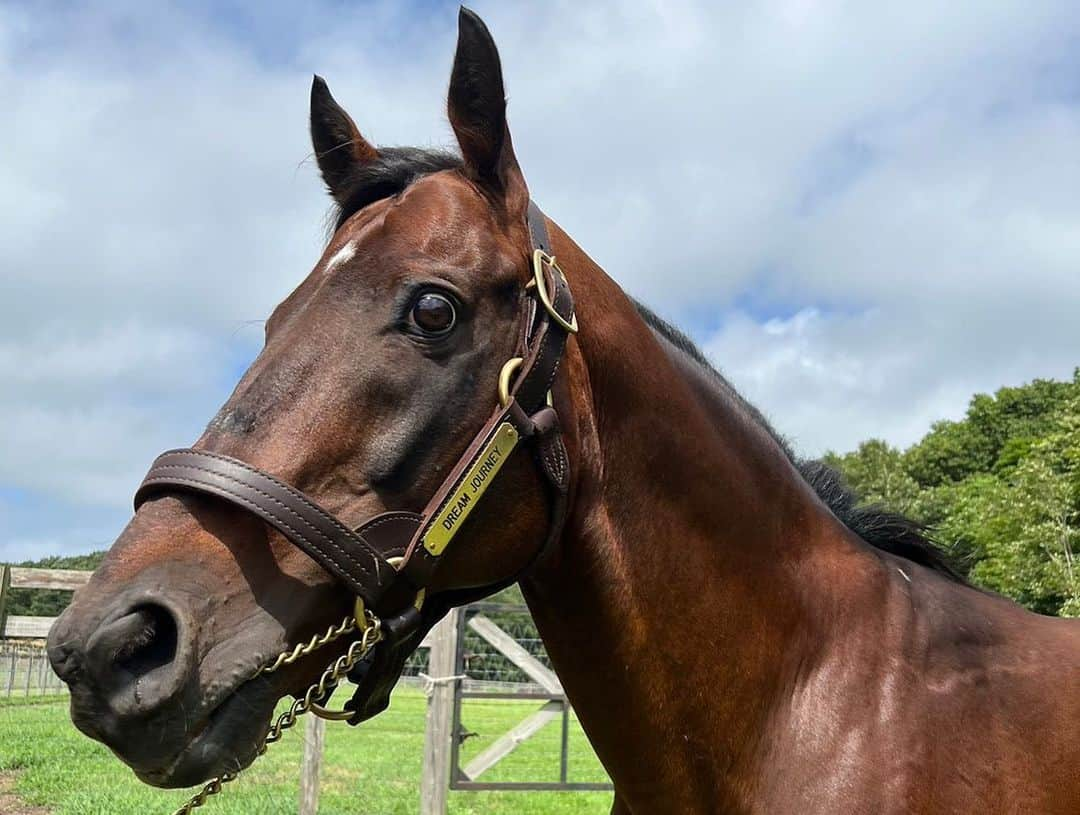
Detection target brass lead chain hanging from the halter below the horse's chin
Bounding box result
[173,611,382,815]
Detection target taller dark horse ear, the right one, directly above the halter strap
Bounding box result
[447,6,528,212]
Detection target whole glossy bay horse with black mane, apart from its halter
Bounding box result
[49,10,1080,815]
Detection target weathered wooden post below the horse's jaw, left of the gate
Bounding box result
[420,609,461,815]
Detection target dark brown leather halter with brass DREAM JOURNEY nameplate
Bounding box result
[135,202,577,628]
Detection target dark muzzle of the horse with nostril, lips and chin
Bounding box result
[48,585,280,787]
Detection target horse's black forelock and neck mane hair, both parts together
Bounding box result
[319,147,964,583]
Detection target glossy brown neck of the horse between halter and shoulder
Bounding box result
[522,227,881,812]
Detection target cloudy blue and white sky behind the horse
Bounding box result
[0,0,1080,561]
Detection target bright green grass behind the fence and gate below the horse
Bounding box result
[0,689,611,815]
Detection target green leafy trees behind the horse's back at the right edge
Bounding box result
[826,369,1080,616]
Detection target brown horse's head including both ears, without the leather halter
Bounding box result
[49,10,578,787]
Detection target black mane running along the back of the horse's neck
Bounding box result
[634,300,966,583]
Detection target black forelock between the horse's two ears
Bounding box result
[329,147,461,231]
